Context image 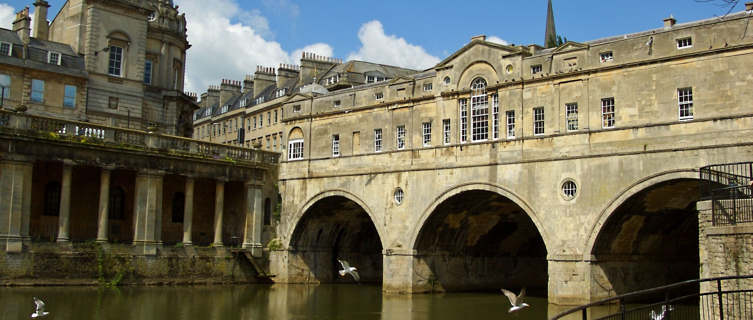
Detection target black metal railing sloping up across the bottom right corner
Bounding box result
[552,275,753,320]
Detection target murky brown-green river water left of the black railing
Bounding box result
[0,285,550,320]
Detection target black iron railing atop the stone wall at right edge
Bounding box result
[700,162,753,226]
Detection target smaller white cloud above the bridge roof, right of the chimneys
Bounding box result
[348,20,439,69]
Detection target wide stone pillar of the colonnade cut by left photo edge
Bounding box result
[0,161,34,252]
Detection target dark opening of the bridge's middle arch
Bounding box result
[414,190,548,296]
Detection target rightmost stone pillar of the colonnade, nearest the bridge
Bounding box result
[243,183,264,258]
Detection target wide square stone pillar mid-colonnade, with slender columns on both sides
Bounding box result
[133,170,163,255]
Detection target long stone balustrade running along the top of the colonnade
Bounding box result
[0,110,280,165]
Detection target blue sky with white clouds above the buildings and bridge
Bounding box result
[0,0,745,93]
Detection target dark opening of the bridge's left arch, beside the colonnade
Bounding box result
[288,195,382,283]
